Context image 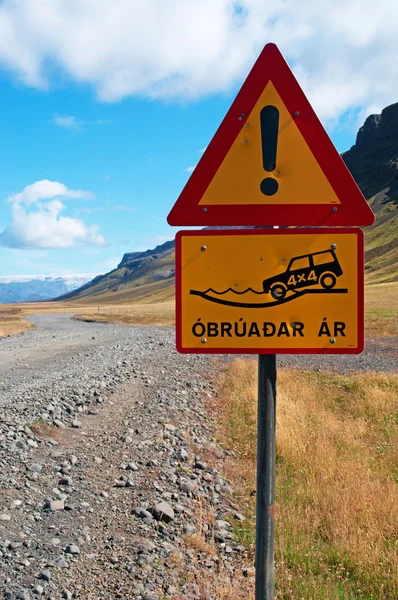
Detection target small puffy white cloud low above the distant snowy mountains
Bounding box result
[0,180,105,249]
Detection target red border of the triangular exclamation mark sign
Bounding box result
[167,44,375,226]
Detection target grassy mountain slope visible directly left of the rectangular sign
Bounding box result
[57,241,175,303]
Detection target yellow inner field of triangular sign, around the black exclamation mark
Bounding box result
[199,81,340,206]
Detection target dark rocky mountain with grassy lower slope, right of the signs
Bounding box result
[343,103,398,283]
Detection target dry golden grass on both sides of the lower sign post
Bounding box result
[213,360,398,600]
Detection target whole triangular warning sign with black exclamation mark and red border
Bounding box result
[167,44,375,226]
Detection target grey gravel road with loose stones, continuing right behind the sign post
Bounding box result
[0,314,398,600]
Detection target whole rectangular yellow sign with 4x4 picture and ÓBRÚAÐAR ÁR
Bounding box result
[176,228,364,354]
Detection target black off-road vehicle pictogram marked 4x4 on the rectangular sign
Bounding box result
[263,249,343,300]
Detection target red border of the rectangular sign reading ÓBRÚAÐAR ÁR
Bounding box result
[175,227,365,354]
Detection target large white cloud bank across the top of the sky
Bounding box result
[0,0,398,127]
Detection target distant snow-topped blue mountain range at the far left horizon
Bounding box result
[0,273,93,304]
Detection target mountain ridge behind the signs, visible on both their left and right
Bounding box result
[60,103,398,303]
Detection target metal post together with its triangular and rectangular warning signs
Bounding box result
[167,44,375,600]
